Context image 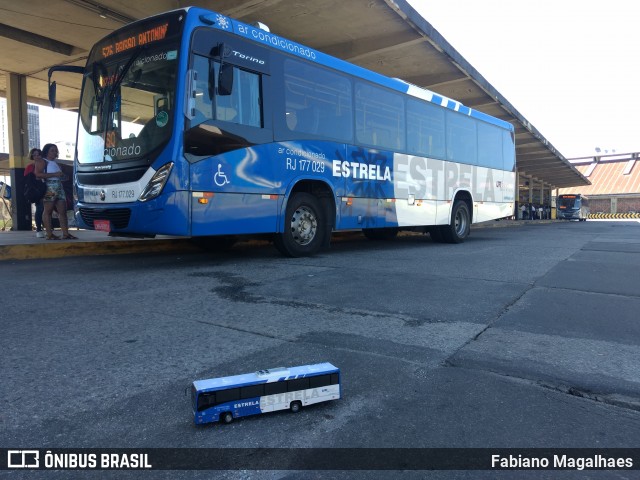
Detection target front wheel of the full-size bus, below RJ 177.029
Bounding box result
[274,192,327,257]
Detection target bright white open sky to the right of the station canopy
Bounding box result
[408,0,640,159]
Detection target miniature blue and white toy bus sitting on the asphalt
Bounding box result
[191,362,340,425]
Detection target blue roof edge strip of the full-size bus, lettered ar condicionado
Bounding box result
[189,7,514,132]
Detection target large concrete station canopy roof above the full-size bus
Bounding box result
[0,0,590,188]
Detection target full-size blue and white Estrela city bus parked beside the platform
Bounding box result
[49,7,515,257]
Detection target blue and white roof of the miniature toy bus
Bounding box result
[193,362,340,392]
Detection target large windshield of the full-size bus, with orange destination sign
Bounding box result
[77,15,181,165]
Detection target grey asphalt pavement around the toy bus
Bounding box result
[0,221,640,479]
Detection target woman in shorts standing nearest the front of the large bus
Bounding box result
[35,143,76,240]
